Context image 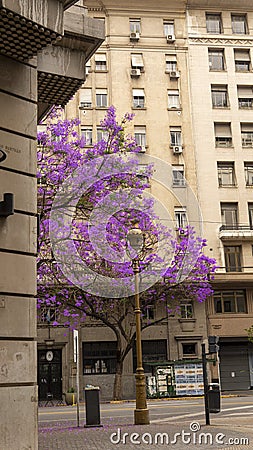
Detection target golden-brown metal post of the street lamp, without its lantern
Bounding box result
[133,259,149,425]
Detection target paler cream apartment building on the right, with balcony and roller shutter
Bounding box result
[187,1,253,389]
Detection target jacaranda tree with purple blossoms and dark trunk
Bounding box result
[38,107,215,399]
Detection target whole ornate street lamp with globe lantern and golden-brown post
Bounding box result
[127,228,149,425]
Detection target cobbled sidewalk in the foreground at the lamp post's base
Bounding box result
[39,415,253,450]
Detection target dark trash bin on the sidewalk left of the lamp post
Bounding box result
[84,386,102,427]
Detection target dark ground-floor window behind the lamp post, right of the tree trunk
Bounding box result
[133,339,167,373]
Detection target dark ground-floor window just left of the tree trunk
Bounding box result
[83,341,117,375]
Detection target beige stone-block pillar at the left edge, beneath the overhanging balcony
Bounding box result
[0,56,38,450]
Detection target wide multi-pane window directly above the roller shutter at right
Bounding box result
[213,290,247,314]
